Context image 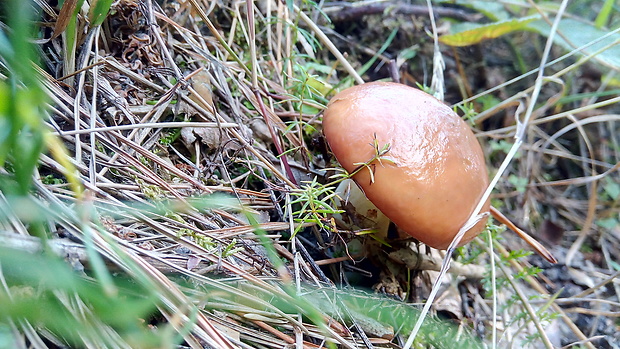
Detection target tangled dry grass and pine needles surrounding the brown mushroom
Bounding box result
[0,0,620,348]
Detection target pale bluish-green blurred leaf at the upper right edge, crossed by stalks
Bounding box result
[528,18,620,69]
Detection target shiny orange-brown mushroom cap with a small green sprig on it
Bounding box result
[323,82,489,249]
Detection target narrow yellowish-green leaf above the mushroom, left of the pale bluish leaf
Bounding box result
[439,15,540,47]
